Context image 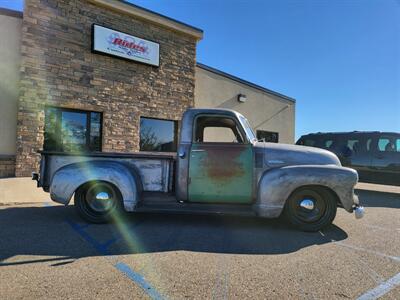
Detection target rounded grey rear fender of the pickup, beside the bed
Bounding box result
[50,160,142,211]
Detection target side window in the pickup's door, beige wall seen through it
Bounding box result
[193,116,245,143]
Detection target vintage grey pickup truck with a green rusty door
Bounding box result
[32,109,364,231]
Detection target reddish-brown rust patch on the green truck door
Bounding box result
[203,147,246,181]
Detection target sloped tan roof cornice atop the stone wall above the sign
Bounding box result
[88,0,203,41]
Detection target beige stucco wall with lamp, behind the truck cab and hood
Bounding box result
[195,66,295,144]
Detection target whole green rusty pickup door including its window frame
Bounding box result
[188,116,253,203]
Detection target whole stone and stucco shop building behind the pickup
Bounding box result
[0,0,294,177]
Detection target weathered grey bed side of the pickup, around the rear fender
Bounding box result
[39,151,176,193]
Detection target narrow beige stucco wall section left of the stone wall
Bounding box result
[0,10,22,156]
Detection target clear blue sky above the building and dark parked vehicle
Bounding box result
[0,0,400,138]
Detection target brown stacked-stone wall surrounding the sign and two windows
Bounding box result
[16,0,196,176]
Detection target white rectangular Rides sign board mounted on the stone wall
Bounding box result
[92,24,160,67]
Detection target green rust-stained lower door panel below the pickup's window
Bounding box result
[189,143,253,203]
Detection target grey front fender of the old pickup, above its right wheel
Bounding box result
[253,165,358,218]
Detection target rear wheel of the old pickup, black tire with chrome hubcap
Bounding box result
[75,181,122,223]
